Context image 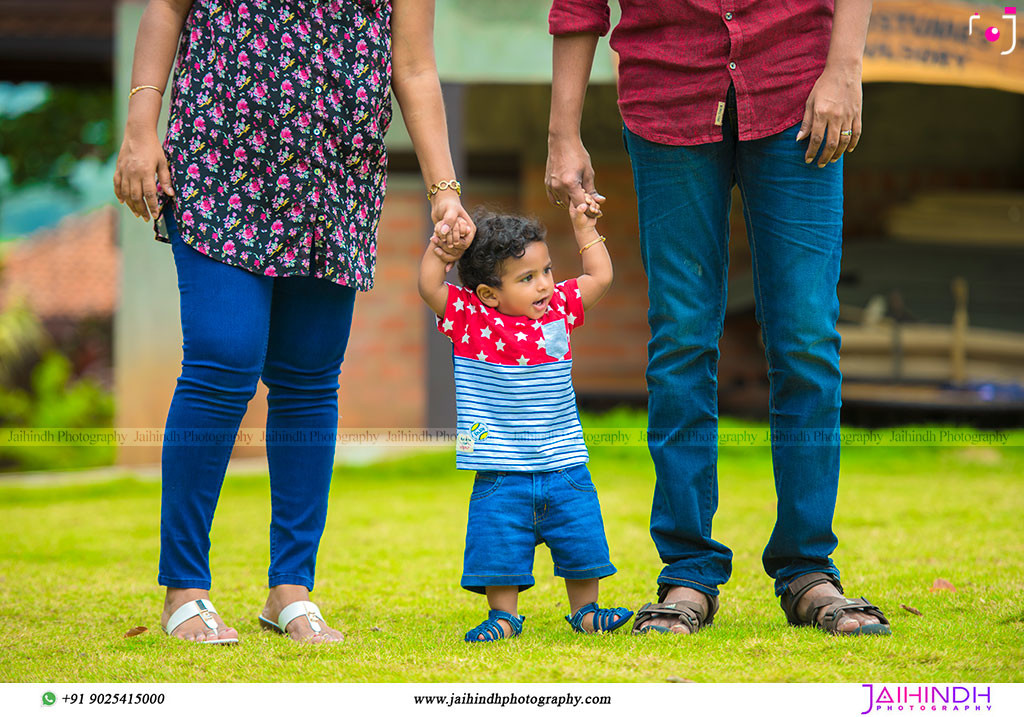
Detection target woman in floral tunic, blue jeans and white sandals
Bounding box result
[114,0,475,643]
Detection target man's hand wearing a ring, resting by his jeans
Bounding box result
[797,65,863,167]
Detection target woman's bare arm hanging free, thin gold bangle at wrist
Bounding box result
[114,0,193,220]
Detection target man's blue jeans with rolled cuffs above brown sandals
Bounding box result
[624,95,843,595]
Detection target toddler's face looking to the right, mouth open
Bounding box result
[476,242,555,319]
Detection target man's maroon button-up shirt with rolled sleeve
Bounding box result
[548,0,834,144]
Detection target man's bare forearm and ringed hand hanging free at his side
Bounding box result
[797,0,871,167]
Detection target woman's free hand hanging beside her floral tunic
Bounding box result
[114,131,174,221]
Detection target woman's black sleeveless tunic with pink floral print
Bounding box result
[157,0,391,291]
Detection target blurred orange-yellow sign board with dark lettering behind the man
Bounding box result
[864,0,1024,93]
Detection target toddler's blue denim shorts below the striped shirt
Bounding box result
[462,464,615,594]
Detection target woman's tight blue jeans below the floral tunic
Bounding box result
[159,207,355,590]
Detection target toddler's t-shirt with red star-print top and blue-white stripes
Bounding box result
[437,279,590,471]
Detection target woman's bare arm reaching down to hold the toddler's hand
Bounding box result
[391,0,476,248]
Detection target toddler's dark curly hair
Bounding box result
[459,208,547,289]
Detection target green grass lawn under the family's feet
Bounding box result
[0,414,1024,682]
